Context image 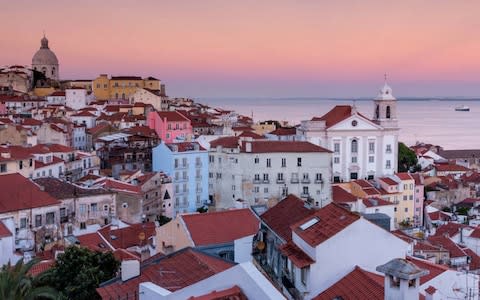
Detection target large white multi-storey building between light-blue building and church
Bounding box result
[209,137,332,208]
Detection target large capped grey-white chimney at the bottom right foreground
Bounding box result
[376,258,429,300]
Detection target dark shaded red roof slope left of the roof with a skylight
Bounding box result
[260,194,315,241]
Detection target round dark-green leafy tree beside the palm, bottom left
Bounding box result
[44,246,120,300]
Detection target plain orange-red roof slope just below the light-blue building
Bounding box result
[181,208,260,246]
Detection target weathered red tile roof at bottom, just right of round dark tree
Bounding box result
[97,247,234,299]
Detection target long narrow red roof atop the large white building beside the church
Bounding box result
[241,140,332,153]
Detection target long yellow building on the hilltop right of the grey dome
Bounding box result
[92,74,164,99]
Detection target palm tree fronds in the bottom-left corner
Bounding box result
[0,259,57,300]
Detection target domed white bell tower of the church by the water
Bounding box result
[373,74,398,128]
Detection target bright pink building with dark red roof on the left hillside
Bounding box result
[147,111,193,143]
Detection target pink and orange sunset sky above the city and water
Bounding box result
[0,0,480,97]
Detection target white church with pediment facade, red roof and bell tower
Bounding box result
[297,82,399,182]
